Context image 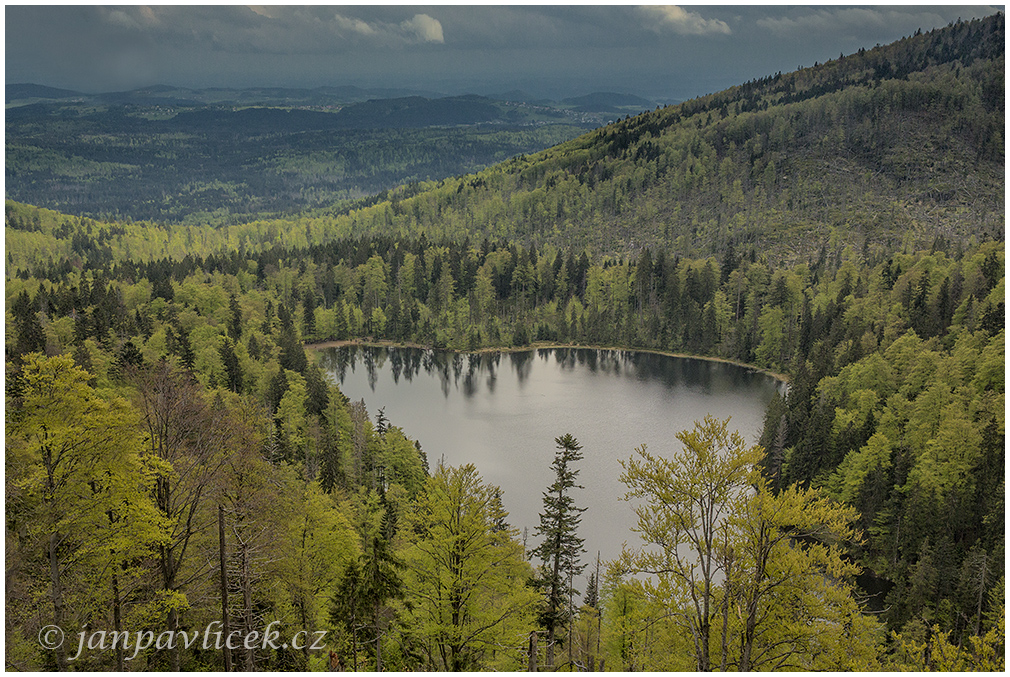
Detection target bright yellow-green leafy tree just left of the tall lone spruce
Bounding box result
[406,465,537,671]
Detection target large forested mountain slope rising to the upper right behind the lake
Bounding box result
[317,14,1005,260]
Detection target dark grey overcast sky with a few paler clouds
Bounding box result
[4,5,1002,100]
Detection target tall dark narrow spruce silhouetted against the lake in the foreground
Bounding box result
[533,433,586,670]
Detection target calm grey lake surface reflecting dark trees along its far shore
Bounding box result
[320,347,783,573]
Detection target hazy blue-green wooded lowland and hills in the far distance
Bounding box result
[5,86,602,221]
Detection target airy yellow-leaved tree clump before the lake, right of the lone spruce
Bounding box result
[617,417,880,671]
